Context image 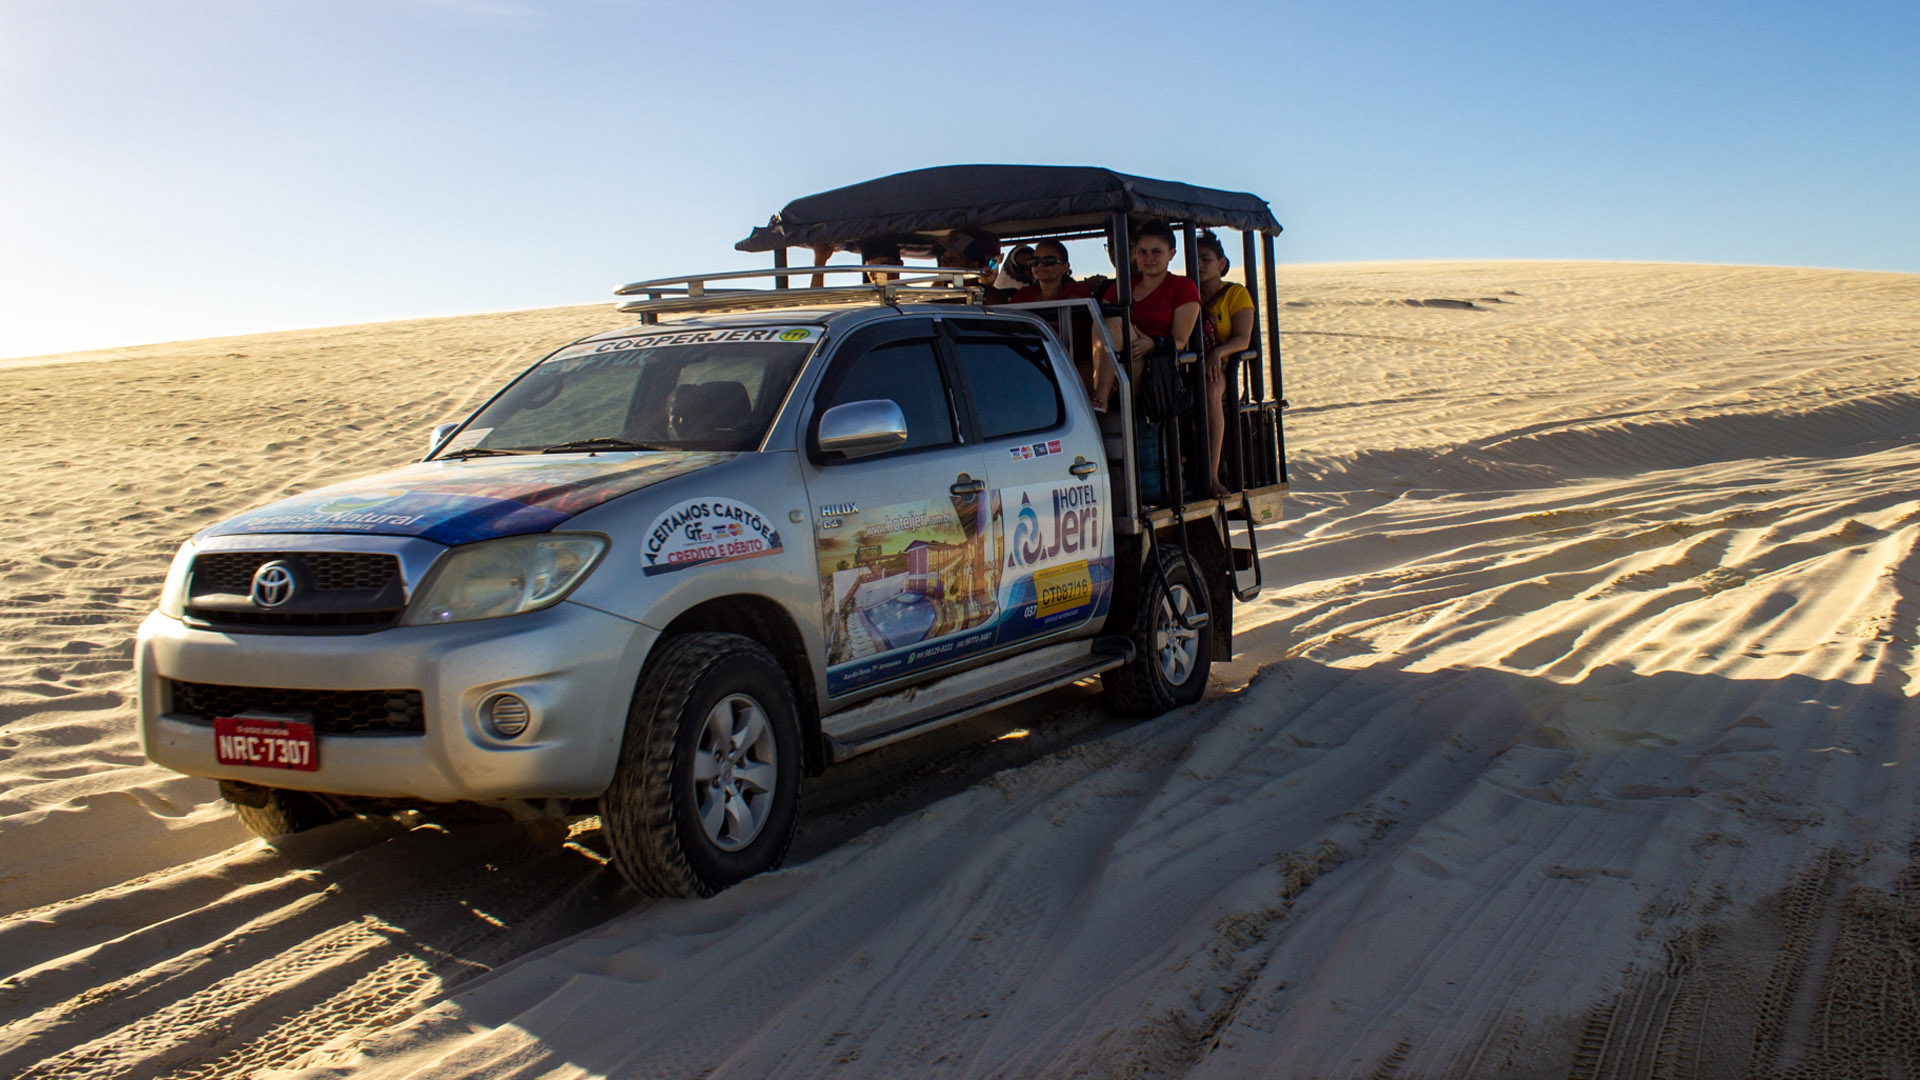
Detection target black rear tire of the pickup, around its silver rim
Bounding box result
[1100,544,1213,717]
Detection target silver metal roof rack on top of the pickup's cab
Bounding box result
[612,263,985,315]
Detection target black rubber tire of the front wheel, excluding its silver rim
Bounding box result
[601,632,801,897]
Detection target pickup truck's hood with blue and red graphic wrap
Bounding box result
[194,452,733,546]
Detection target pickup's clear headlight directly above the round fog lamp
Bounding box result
[401,532,607,626]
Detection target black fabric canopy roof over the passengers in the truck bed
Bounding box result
[733,165,1281,252]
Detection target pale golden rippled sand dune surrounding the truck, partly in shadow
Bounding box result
[0,263,1920,1080]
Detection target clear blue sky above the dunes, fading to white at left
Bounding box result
[0,0,1920,357]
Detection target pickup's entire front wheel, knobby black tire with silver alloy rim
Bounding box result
[601,634,801,897]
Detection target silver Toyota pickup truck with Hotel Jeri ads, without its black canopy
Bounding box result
[136,167,1284,896]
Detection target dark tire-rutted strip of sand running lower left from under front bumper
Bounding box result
[0,819,636,1080]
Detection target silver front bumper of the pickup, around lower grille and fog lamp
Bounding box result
[134,601,659,801]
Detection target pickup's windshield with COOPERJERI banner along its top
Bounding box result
[440,327,822,455]
